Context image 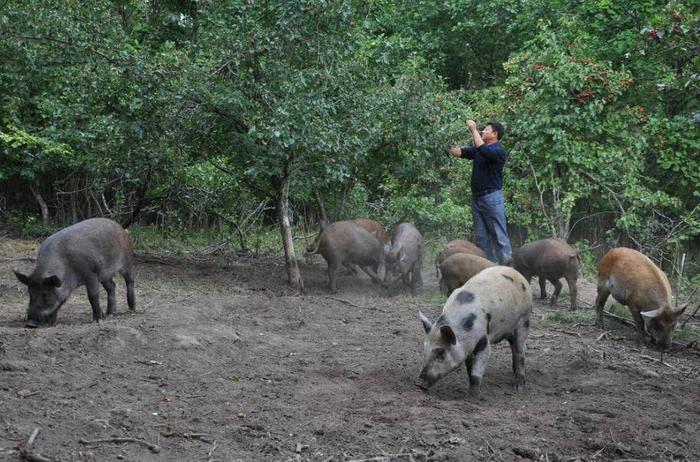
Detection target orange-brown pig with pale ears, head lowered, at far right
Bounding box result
[595,247,688,349]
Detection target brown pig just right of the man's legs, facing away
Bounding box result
[512,239,579,310]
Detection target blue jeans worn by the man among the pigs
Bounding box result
[472,191,512,265]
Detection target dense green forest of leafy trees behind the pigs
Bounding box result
[0,0,700,286]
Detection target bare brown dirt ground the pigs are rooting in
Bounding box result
[0,239,700,462]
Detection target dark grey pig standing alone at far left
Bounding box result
[15,218,136,328]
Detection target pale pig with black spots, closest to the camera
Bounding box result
[416,266,532,398]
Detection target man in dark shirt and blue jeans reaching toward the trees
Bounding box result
[448,120,512,265]
